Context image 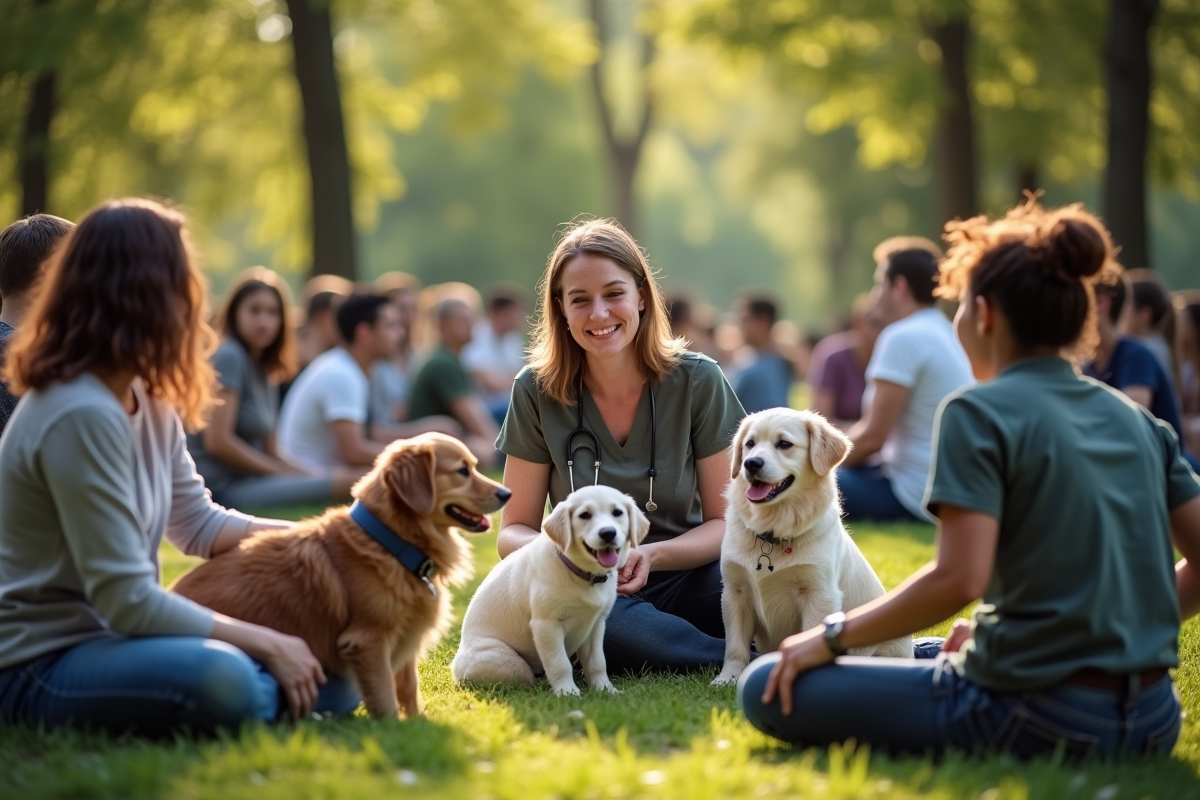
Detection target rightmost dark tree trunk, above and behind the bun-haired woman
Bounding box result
[1104,0,1158,269]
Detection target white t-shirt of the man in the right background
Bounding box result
[863,308,973,519]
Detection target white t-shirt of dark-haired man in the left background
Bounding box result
[277,347,371,471]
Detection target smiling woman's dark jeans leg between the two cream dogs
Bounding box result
[604,561,725,675]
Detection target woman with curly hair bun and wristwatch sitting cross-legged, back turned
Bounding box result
[738,199,1200,757]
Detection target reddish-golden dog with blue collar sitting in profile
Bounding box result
[172,433,510,717]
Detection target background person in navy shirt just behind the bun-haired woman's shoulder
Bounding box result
[1084,272,1200,469]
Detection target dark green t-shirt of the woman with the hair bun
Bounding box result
[925,357,1200,692]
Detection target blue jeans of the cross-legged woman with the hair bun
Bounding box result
[738,654,1181,758]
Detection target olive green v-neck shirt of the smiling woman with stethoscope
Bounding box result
[496,353,745,542]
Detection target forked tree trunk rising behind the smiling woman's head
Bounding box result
[589,0,654,239]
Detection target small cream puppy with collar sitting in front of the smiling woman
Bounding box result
[450,486,650,696]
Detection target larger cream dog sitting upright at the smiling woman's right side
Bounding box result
[713,408,912,685]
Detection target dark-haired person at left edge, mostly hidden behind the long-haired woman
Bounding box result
[0,213,74,433]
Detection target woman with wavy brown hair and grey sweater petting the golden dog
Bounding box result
[0,200,358,735]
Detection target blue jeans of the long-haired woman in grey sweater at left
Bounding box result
[0,636,359,736]
